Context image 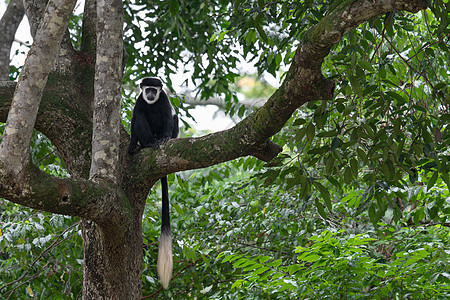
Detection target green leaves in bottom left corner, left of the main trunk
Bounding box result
[0,200,83,299]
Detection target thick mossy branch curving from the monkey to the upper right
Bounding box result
[131,0,427,180]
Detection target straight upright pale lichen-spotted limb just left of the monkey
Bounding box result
[90,0,123,183]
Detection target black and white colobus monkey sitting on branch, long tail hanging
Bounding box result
[128,77,179,288]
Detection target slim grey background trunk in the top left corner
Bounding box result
[0,0,25,80]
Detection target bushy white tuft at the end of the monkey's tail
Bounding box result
[156,231,173,289]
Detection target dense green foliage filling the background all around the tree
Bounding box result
[0,0,450,299]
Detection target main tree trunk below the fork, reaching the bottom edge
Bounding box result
[81,216,143,299]
